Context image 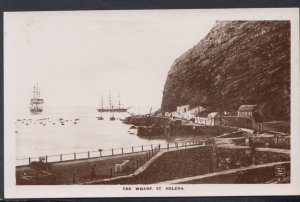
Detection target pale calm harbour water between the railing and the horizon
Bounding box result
[15,108,166,158]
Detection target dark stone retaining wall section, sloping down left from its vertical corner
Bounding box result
[88,146,212,184]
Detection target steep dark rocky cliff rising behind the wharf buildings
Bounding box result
[161,21,290,121]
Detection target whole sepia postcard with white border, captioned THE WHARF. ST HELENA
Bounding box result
[4,9,299,197]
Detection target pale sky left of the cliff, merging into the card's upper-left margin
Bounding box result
[4,10,216,112]
